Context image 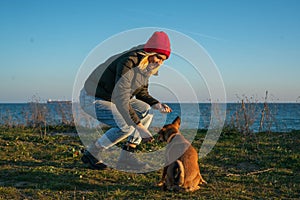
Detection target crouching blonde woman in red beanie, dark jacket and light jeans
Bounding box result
[80,31,172,170]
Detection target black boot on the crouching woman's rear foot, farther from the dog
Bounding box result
[81,143,107,170]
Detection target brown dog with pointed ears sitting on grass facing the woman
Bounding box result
[158,117,206,192]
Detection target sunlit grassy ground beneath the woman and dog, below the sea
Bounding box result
[0,127,300,199]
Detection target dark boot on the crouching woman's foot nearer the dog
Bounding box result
[117,145,150,170]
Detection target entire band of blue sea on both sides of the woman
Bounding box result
[0,102,300,132]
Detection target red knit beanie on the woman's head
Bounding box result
[144,31,171,59]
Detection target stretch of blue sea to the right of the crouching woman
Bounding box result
[152,103,300,132]
